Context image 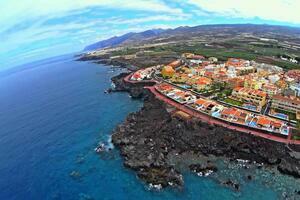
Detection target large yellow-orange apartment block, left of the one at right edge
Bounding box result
[231,87,267,107]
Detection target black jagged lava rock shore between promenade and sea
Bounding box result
[112,74,300,187]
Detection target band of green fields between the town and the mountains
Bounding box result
[111,39,300,70]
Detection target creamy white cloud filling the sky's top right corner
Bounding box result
[188,0,300,24]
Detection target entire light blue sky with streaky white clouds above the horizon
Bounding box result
[0,0,300,71]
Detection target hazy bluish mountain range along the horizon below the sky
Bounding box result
[84,24,300,51]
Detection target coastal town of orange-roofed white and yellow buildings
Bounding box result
[128,53,300,142]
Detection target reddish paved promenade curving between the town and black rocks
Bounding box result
[124,73,300,145]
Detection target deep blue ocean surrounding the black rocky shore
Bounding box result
[0,55,300,200]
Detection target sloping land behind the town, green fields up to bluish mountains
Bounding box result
[80,24,300,69]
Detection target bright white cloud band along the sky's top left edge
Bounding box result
[0,0,183,27]
